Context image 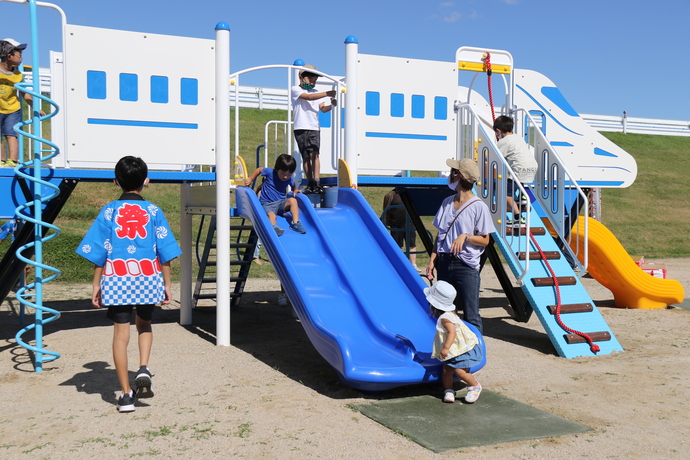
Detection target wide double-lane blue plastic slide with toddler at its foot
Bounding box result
[236,187,486,391]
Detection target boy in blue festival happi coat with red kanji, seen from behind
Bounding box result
[76,156,182,412]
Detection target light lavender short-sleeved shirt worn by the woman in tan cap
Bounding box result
[433,195,496,269]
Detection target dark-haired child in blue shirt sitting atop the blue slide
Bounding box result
[244,153,307,236]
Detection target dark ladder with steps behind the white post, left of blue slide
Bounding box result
[192,216,258,308]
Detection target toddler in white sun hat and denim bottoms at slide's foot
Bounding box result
[424,281,483,403]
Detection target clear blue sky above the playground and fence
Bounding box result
[0,0,690,120]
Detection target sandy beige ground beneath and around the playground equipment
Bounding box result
[0,259,690,459]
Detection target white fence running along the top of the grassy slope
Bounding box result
[24,68,690,136]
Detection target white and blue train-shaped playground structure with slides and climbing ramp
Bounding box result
[0,1,683,390]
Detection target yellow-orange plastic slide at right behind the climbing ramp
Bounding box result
[571,216,685,309]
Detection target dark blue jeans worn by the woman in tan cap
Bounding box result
[436,253,484,334]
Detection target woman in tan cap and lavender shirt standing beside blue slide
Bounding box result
[426,158,495,333]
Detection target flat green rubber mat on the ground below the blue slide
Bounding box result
[353,390,591,452]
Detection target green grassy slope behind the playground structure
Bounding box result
[0,109,690,283]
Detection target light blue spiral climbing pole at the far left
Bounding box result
[14,0,60,372]
